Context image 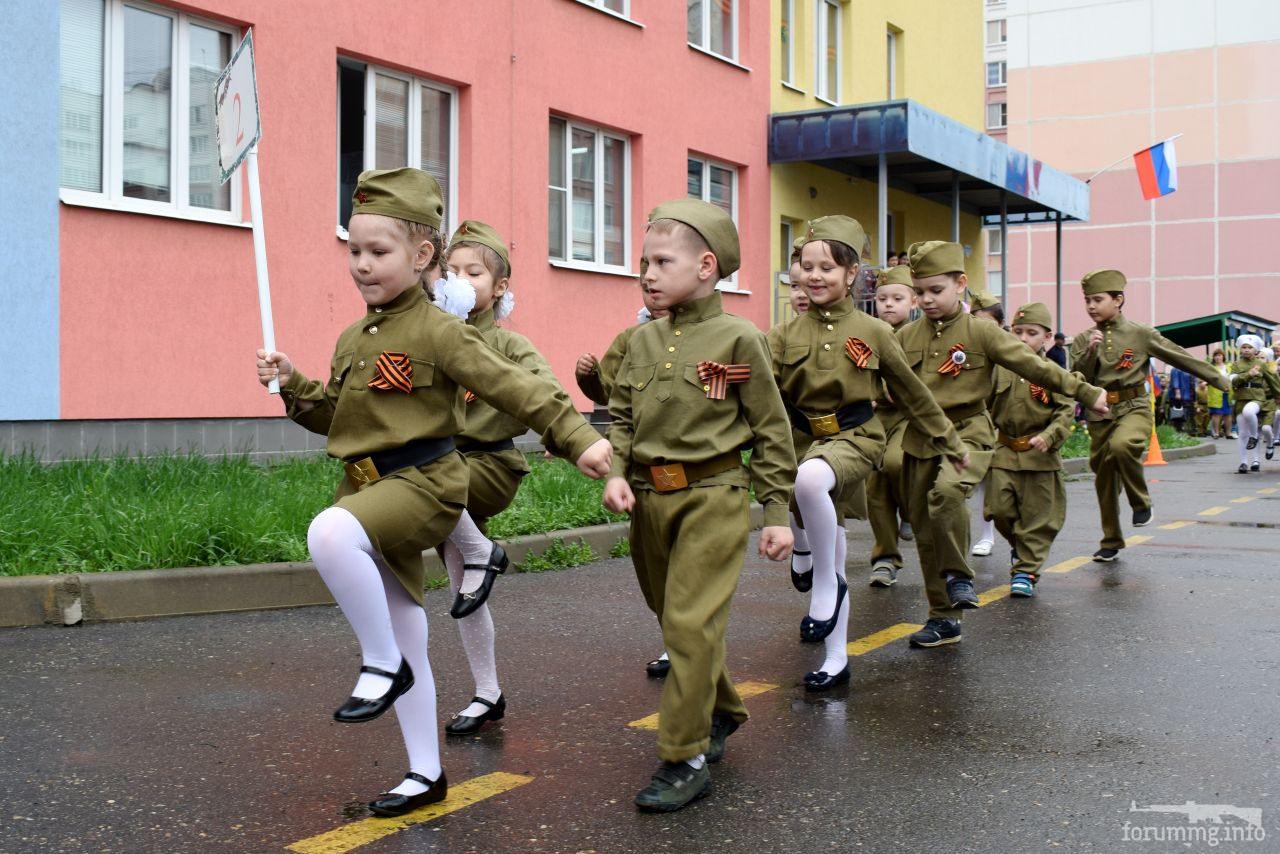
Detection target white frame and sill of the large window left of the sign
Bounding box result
[58,0,250,228]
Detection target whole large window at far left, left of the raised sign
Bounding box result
[59,0,239,222]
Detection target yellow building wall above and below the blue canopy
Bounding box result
[769,0,986,321]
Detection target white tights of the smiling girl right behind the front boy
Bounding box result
[795,460,849,675]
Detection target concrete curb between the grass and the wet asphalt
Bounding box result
[0,442,1217,629]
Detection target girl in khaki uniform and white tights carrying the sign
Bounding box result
[257,169,611,816]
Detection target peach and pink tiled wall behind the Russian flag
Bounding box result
[1007,33,1280,334]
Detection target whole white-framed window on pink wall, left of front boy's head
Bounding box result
[547,117,631,270]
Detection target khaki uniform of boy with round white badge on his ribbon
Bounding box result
[897,311,1101,620]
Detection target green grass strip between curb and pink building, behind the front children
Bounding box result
[0,455,621,576]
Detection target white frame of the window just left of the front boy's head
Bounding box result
[547,113,634,277]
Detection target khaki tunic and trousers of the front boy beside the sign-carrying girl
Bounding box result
[609,293,795,762]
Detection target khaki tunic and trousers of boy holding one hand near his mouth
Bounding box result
[1071,314,1229,549]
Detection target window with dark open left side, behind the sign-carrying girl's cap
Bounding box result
[338,58,458,236]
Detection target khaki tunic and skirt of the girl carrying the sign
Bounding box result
[280,288,600,602]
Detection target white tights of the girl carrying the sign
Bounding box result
[307,507,440,795]
